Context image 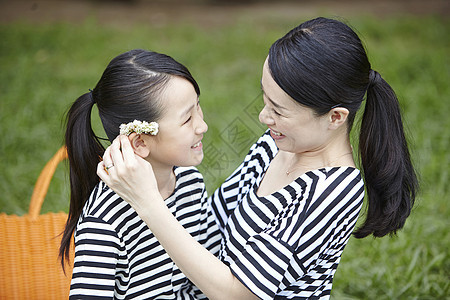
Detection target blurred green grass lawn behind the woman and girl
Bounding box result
[0,13,450,299]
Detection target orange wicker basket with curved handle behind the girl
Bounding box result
[0,147,73,299]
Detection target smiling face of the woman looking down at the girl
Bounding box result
[259,59,329,153]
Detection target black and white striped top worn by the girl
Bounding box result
[70,167,221,299]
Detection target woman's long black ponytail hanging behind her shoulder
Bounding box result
[354,70,418,238]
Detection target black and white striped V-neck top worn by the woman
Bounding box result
[209,132,364,299]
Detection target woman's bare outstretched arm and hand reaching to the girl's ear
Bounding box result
[97,136,258,300]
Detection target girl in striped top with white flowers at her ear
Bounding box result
[60,50,220,299]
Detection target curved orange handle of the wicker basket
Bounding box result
[28,146,67,218]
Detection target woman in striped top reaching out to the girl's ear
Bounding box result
[97,18,417,299]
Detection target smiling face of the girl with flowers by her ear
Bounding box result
[144,76,208,167]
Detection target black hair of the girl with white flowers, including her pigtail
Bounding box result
[59,49,200,268]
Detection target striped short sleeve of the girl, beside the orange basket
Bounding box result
[70,217,122,299]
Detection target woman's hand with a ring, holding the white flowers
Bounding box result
[97,135,162,214]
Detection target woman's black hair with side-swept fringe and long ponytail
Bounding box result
[269,18,418,238]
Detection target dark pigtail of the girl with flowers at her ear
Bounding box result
[59,92,105,269]
